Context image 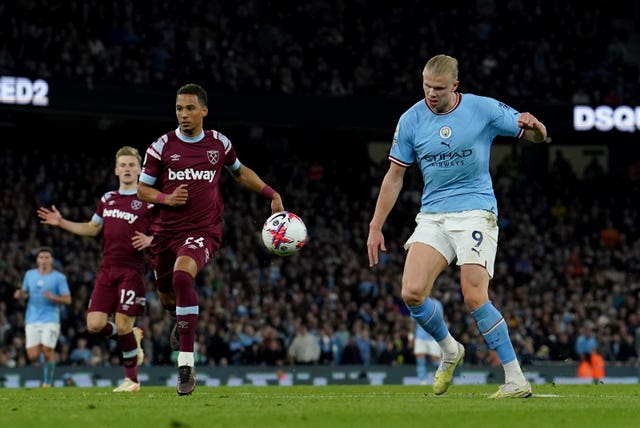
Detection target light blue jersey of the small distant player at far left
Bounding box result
[22,269,71,324]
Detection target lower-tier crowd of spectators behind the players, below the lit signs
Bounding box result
[0,138,640,372]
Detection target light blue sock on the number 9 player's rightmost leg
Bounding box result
[471,301,516,365]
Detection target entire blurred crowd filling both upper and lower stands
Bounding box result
[0,0,640,367]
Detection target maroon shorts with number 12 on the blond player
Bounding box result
[89,265,146,316]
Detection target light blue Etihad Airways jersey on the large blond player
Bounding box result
[389,93,524,215]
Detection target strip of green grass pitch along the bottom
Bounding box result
[0,385,640,428]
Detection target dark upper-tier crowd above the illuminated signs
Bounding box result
[0,0,640,105]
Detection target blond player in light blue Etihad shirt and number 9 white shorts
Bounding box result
[367,55,547,398]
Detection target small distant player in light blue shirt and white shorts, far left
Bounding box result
[13,247,71,388]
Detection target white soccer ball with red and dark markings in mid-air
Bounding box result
[262,211,307,256]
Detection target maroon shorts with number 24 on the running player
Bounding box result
[151,225,222,284]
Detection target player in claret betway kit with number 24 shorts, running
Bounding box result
[138,83,284,395]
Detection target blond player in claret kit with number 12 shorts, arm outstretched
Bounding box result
[38,146,153,392]
